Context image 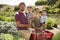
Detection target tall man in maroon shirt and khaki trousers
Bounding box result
[15,2,30,40]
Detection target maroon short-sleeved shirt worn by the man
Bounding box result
[15,12,28,30]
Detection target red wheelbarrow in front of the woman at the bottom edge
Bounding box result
[30,30,53,40]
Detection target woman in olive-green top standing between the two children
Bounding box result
[32,8,41,29]
